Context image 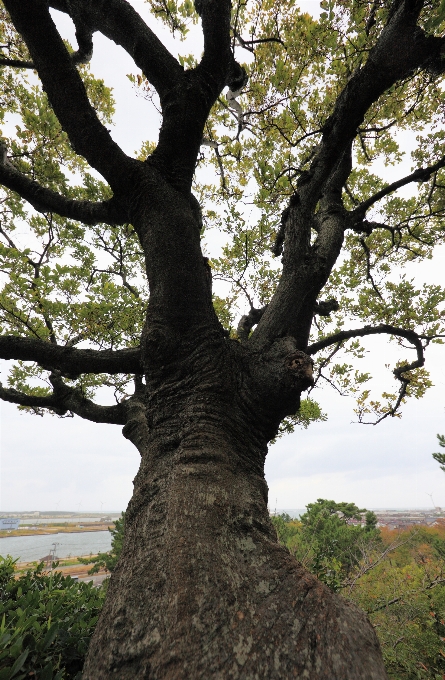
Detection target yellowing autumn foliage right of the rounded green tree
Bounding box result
[352,527,445,680]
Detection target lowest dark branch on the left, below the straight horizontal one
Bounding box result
[0,373,126,425]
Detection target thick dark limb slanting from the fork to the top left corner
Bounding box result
[4,0,136,190]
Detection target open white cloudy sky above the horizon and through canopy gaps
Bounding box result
[0,0,445,511]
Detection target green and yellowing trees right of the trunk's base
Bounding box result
[272,499,445,680]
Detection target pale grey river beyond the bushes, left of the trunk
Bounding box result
[0,531,111,562]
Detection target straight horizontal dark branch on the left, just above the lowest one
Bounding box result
[0,335,141,377]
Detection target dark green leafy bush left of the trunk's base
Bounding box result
[0,556,104,680]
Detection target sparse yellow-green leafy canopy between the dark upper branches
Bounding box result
[0,0,445,424]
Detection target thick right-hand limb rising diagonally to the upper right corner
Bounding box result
[250,5,445,350]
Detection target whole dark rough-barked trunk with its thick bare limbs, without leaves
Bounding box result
[0,0,444,680]
